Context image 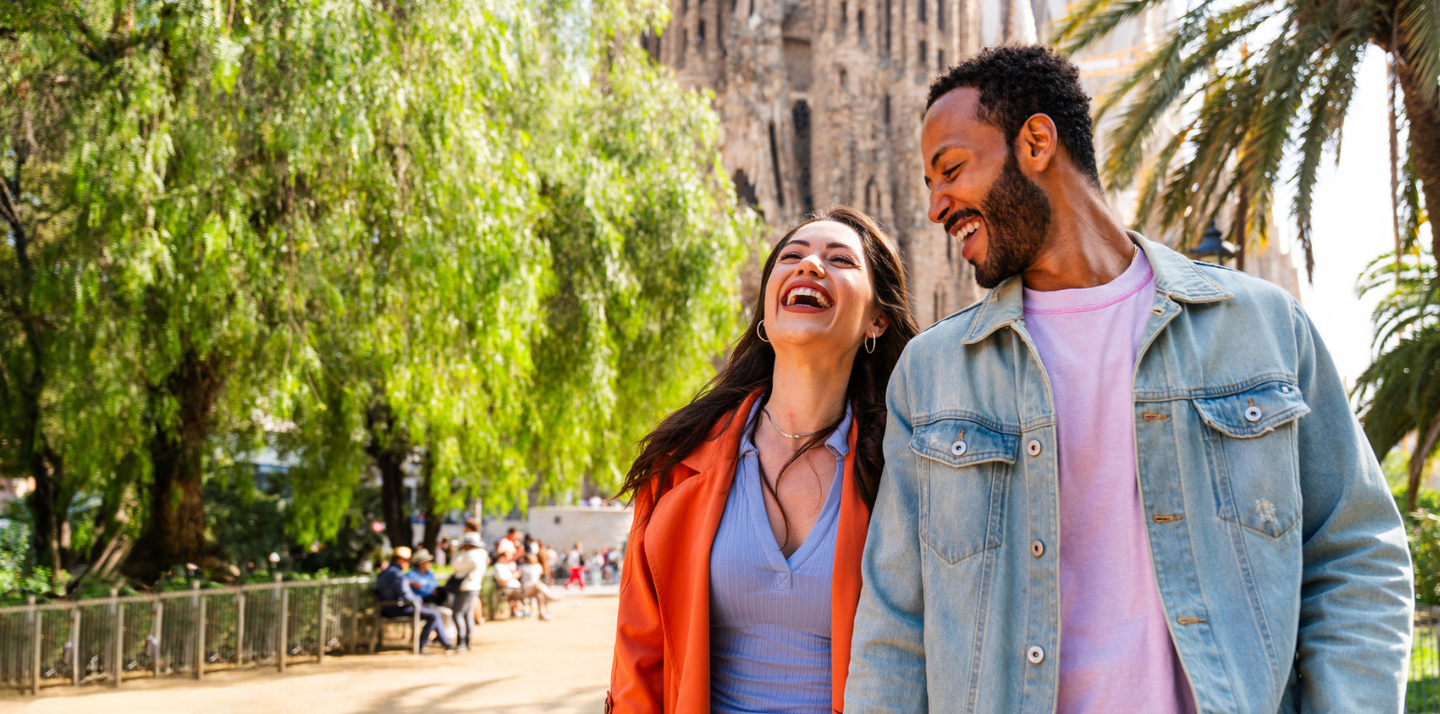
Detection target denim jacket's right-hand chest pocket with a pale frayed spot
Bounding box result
[1194,380,1310,538]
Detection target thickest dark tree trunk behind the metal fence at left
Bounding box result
[130,353,225,580]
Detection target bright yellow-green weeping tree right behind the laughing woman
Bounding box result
[264,1,757,547]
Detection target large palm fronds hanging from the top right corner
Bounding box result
[1054,0,1440,269]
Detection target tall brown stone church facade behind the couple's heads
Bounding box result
[641,0,1293,327]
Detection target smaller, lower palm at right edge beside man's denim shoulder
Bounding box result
[1355,252,1440,512]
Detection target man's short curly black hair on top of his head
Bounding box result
[924,45,1100,187]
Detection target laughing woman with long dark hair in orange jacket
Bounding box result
[606,207,916,714]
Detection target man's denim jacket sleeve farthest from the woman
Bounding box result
[1286,302,1414,713]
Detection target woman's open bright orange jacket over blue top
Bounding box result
[605,393,870,714]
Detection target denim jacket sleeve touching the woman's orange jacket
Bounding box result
[845,358,929,714]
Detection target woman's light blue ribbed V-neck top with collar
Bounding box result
[710,403,851,714]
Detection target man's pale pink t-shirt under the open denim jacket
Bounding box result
[1025,250,1195,714]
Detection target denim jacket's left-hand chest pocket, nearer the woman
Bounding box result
[910,416,1020,564]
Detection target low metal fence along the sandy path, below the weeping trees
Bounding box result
[0,577,418,692]
